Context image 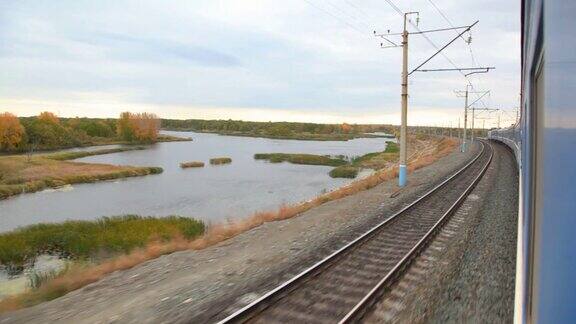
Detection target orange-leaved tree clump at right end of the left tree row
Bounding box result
[117,112,160,142]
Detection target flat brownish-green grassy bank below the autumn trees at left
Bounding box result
[0,146,163,199]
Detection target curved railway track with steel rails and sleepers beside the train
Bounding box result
[219,142,493,324]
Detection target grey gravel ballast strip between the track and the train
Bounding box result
[367,142,518,323]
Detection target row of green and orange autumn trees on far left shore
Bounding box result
[0,112,160,152]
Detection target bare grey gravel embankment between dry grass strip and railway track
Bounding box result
[0,139,478,323]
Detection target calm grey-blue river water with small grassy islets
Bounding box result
[0,132,386,231]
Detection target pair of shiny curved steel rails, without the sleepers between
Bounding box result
[219,142,493,324]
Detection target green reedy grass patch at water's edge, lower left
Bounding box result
[0,215,204,267]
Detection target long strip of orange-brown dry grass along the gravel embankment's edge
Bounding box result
[0,138,457,312]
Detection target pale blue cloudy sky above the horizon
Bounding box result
[0,0,520,127]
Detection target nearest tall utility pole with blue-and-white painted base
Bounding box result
[398,14,408,187]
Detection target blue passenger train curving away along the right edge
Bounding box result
[488,0,576,323]
